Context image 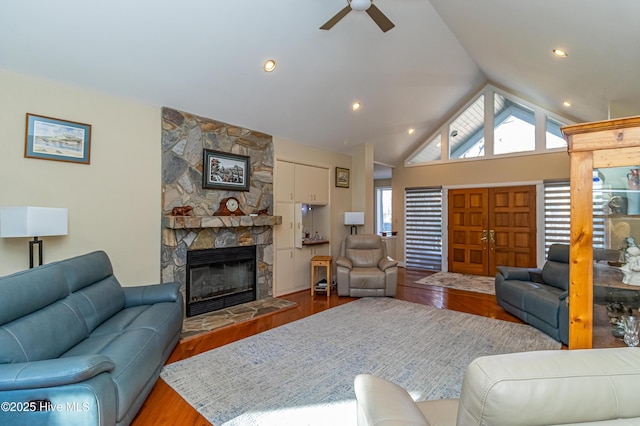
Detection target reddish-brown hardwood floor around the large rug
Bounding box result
[132,268,521,426]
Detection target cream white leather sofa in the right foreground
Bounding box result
[354,348,640,426]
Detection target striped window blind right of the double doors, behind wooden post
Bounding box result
[544,180,606,258]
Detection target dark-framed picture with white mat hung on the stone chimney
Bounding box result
[202,149,250,191]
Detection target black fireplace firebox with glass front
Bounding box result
[186,246,257,317]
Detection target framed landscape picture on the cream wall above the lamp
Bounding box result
[24,113,91,164]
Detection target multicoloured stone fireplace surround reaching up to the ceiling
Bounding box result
[161,108,282,315]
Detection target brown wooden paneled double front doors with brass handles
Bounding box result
[448,185,536,276]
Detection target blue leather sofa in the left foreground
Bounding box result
[0,251,183,426]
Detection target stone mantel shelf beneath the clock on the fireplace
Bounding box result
[162,216,282,229]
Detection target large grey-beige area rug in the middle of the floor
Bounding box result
[161,298,560,426]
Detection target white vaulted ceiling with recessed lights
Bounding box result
[0,0,640,169]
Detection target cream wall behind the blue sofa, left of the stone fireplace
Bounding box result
[0,70,161,286]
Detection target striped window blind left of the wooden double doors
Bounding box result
[405,187,442,271]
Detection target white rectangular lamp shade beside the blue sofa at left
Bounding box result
[0,206,68,238]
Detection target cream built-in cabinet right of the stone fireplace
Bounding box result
[273,160,331,296]
